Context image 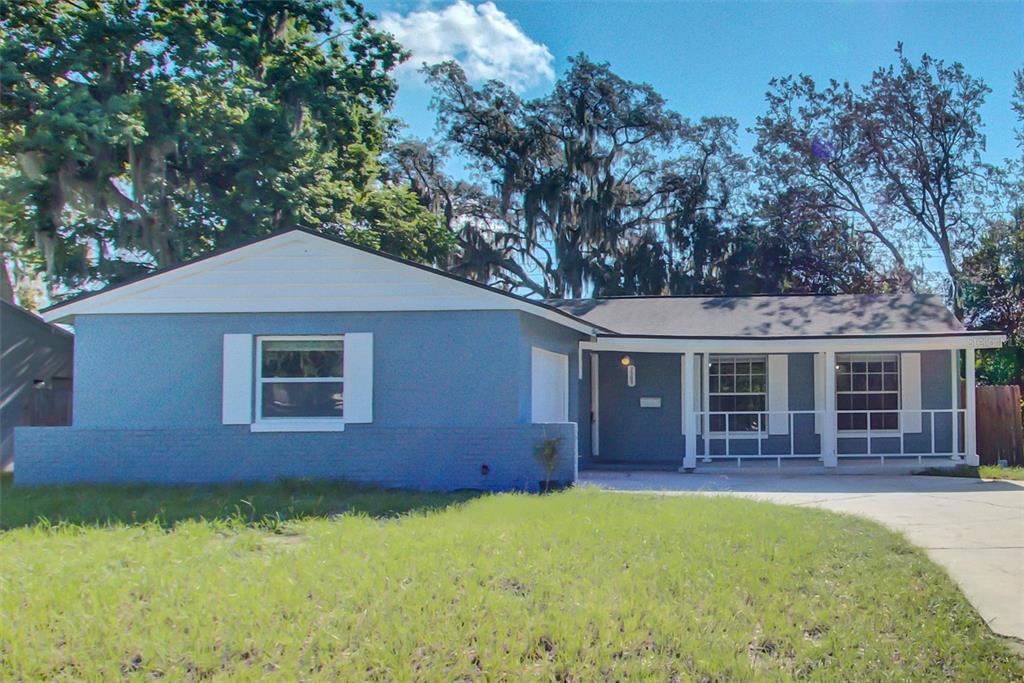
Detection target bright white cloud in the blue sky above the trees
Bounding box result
[377,0,555,91]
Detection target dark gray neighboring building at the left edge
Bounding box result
[0,300,74,471]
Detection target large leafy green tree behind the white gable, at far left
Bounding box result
[0,0,452,301]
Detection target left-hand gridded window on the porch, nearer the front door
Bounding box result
[708,355,768,432]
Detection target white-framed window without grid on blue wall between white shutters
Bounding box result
[256,336,345,421]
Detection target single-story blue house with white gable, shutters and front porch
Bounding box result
[17,230,1002,489]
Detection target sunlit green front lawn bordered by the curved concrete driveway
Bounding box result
[0,483,1024,681]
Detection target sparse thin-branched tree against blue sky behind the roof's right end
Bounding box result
[755,46,989,318]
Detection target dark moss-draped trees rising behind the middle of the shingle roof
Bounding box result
[407,55,880,297]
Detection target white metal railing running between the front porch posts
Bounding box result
[695,409,967,467]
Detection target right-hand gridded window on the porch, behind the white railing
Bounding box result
[836,353,899,431]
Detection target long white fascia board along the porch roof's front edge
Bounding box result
[580,334,1006,353]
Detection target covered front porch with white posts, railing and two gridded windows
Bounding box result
[579,336,998,474]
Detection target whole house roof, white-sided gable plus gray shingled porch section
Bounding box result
[42,229,1000,348]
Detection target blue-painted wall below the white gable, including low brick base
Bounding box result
[17,311,579,488]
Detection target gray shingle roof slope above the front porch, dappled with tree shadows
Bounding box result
[546,294,976,338]
